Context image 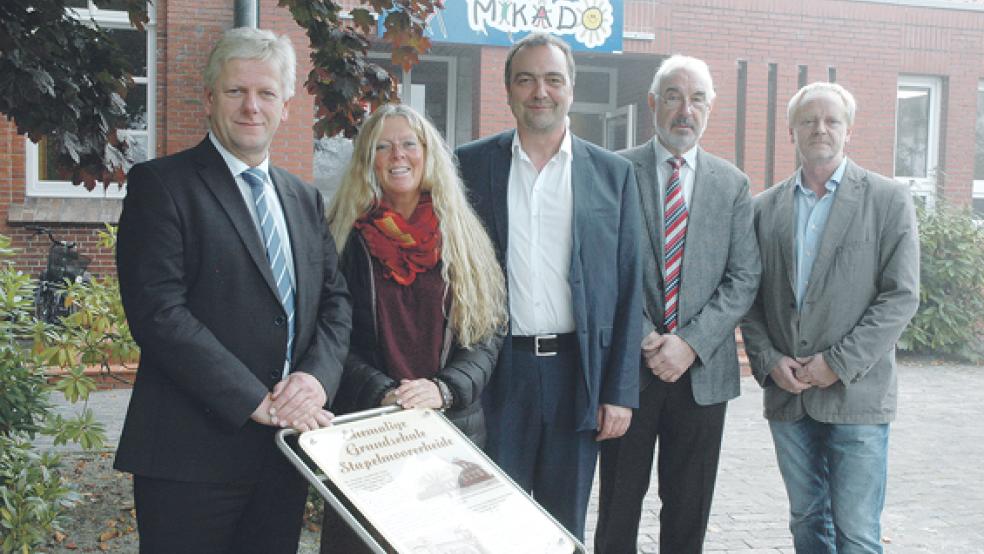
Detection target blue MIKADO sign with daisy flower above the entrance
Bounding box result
[402,0,623,52]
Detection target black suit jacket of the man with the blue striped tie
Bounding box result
[116,138,351,482]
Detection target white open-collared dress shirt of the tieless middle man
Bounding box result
[506,130,574,335]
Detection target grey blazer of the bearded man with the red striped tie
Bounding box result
[620,139,761,406]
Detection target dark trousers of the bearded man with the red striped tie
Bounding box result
[594,373,727,554]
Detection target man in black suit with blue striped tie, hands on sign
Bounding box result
[116,29,351,554]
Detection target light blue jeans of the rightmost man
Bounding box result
[769,416,888,554]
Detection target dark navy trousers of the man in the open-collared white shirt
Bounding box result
[486,349,598,541]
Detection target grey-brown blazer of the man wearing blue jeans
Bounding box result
[742,160,919,424]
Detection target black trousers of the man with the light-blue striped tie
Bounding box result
[133,441,308,554]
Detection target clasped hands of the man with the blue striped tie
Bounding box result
[251,372,335,433]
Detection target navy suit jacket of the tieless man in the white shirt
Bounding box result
[457,131,642,431]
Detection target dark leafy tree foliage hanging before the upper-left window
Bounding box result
[0,0,147,190]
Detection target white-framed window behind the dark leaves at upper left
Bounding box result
[25,0,156,198]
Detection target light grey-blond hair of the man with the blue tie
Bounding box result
[203,27,297,100]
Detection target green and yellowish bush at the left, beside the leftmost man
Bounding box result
[0,229,137,553]
